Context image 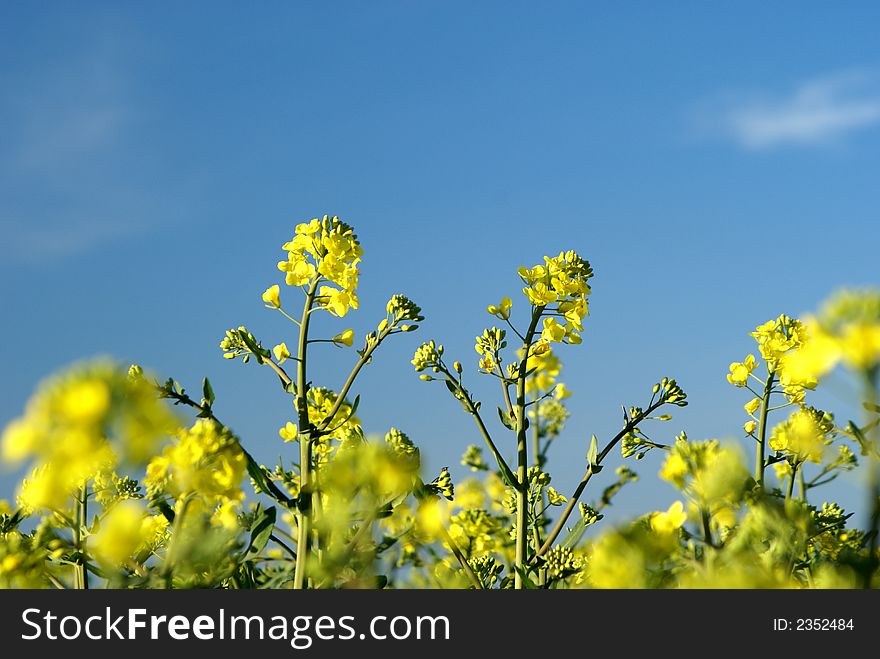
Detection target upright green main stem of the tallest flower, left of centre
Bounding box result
[293,277,319,589]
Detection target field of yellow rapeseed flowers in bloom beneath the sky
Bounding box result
[0,216,880,589]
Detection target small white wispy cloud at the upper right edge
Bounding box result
[698,72,880,150]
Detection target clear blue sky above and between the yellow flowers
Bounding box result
[0,2,880,514]
